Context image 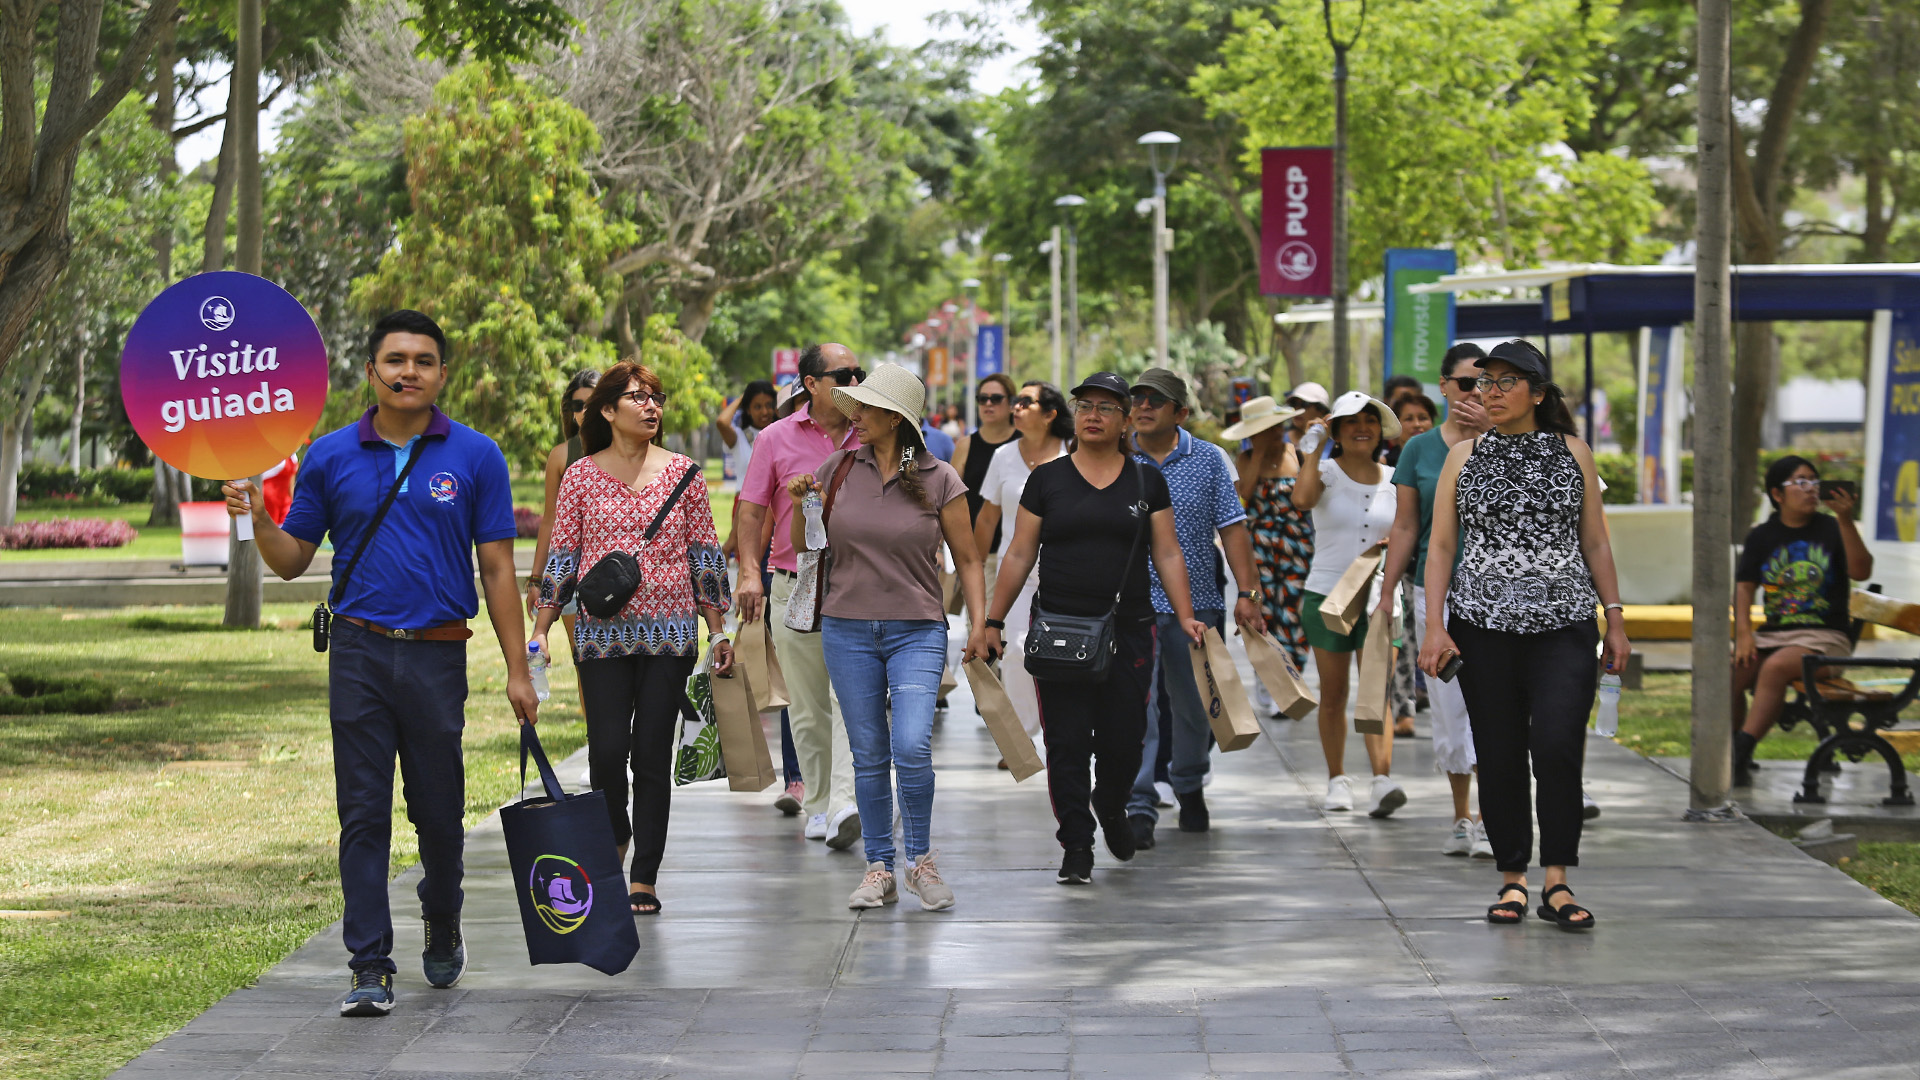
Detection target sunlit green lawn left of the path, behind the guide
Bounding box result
[0,599,586,1080]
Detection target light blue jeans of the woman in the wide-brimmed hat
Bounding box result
[820,615,947,871]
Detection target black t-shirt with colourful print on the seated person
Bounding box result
[1734,513,1853,634]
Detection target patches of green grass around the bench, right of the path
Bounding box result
[1615,675,1920,915]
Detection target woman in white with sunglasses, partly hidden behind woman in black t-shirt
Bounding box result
[973,380,1073,737]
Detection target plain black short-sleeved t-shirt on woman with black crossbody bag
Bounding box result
[1020,457,1173,623]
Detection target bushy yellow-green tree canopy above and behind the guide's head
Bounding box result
[353,63,634,465]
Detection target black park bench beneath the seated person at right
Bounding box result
[1780,584,1920,807]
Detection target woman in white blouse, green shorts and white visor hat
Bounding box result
[1294,390,1407,817]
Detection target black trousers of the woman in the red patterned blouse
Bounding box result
[580,655,695,886]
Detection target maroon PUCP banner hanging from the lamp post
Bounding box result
[1260,146,1332,296]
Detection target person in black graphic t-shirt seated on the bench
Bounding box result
[1734,455,1874,788]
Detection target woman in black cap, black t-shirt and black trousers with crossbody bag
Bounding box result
[973,371,1206,884]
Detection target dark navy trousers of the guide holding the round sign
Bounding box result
[326,619,467,974]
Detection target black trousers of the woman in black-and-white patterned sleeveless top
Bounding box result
[1448,617,1599,874]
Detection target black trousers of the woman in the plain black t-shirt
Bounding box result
[1033,623,1154,849]
